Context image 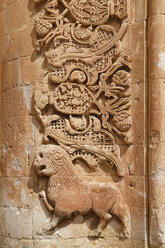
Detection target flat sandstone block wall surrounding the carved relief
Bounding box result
[0,0,151,248]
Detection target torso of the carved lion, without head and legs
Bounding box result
[47,176,119,216]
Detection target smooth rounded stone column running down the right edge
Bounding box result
[149,0,165,247]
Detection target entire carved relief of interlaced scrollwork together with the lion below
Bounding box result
[34,0,132,236]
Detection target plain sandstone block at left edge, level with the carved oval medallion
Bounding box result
[3,88,32,147]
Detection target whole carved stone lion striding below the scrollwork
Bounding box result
[33,145,130,237]
